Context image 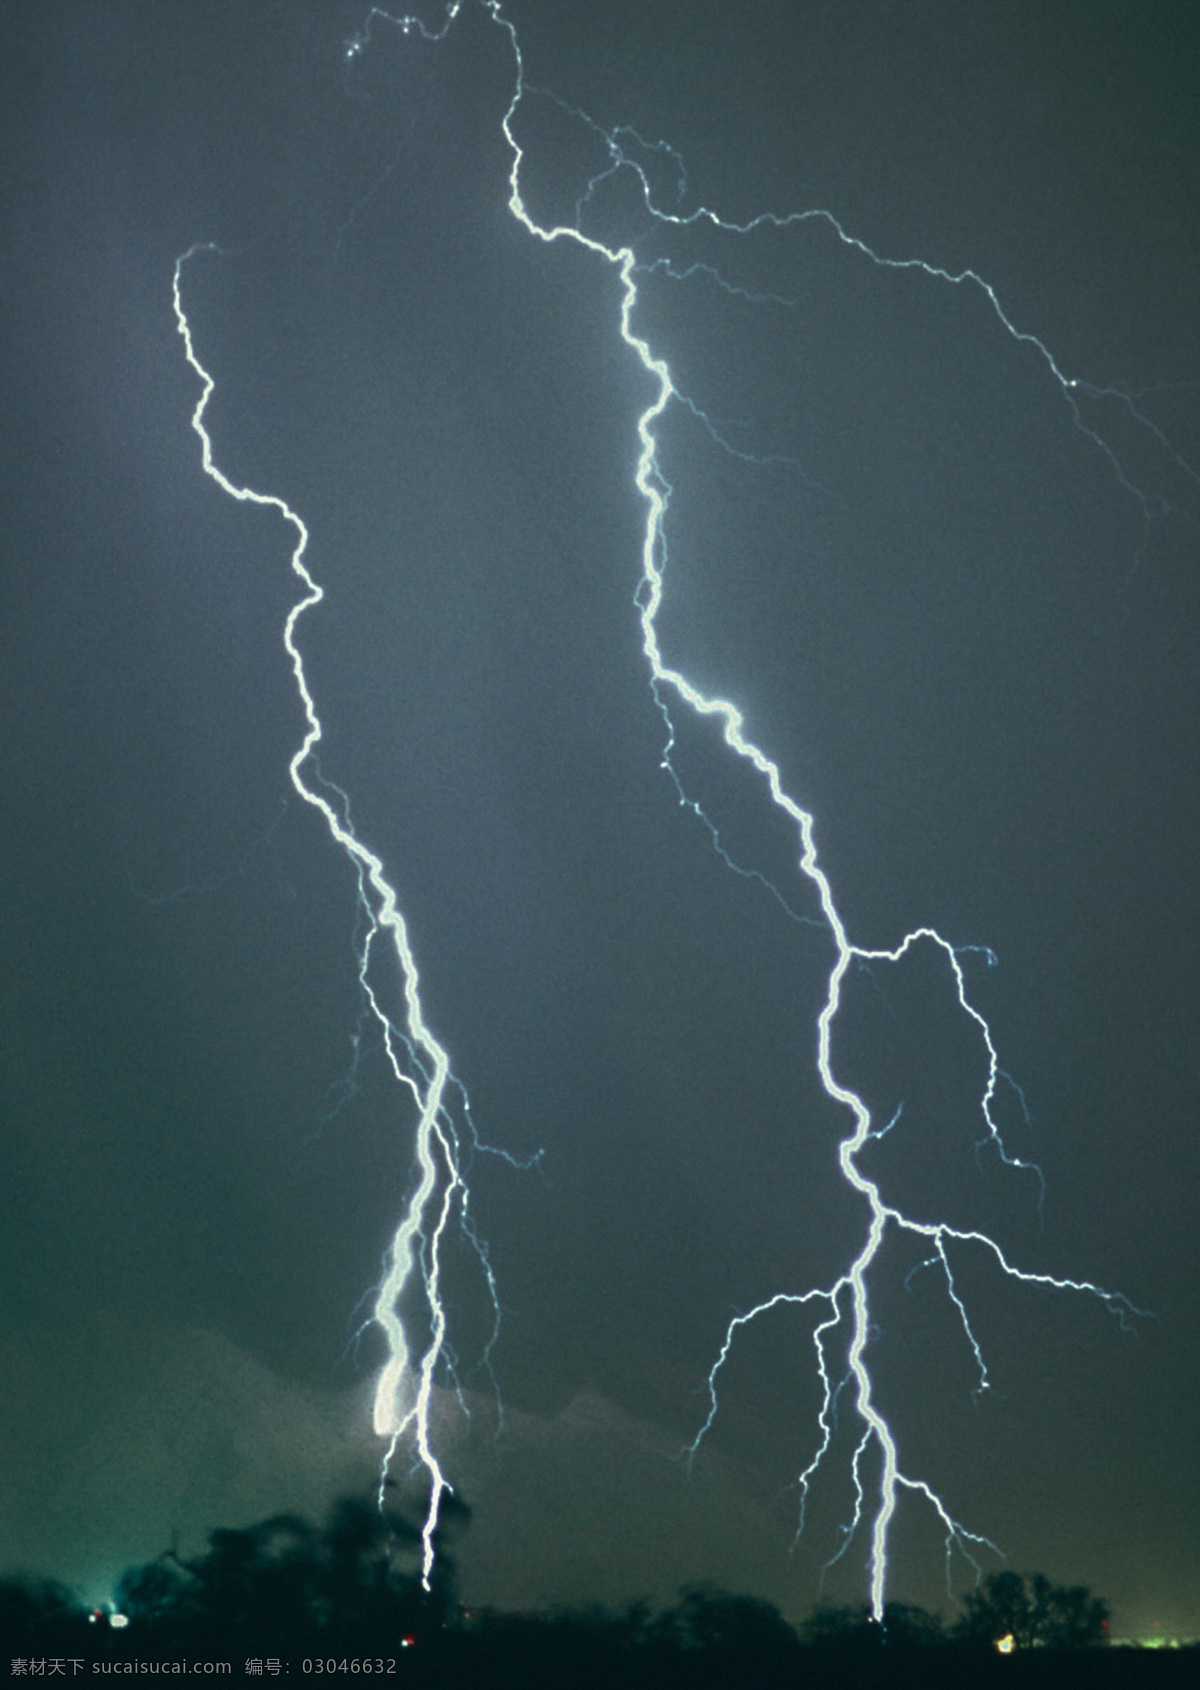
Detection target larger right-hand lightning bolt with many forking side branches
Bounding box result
[427,0,1153,1621]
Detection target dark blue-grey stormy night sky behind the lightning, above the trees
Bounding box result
[0,0,1200,1631]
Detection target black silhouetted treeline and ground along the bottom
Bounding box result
[0,1499,1200,1690]
